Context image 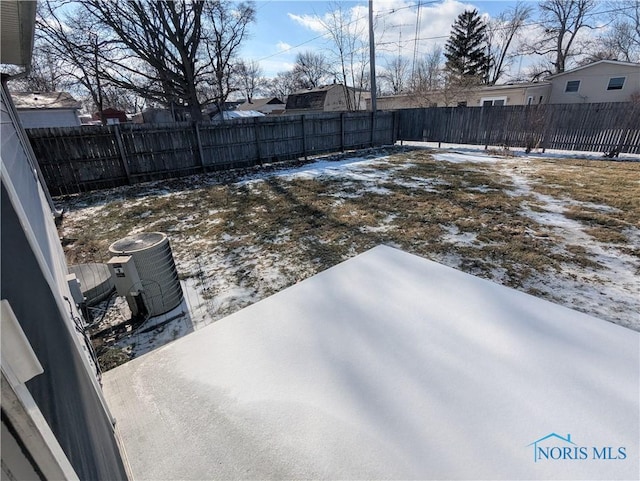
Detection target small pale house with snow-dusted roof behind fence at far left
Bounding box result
[11,92,82,129]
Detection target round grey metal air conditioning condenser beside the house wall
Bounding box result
[107,232,183,317]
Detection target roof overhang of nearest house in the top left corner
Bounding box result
[0,0,36,66]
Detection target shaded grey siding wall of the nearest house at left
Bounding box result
[0,80,127,480]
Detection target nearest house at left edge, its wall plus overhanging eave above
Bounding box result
[0,0,127,480]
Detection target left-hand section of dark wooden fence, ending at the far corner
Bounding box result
[27,112,396,195]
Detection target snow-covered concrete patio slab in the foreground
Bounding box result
[103,246,640,479]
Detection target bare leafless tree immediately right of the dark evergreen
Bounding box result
[487,2,533,85]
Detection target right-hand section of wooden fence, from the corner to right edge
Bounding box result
[398,103,640,154]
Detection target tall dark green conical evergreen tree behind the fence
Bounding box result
[444,10,490,84]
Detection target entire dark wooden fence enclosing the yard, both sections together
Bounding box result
[27,103,640,195]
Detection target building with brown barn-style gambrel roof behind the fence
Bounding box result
[285,84,366,114]
